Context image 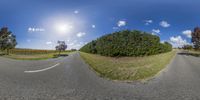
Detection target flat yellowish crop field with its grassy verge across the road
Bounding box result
[0,49,72,60]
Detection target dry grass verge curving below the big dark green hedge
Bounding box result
[80,50,176,81]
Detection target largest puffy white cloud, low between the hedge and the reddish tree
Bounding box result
[170,35,190,47]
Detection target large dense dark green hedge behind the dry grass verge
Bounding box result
[80,30,172,56]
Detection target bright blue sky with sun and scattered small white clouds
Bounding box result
[0,0,200,49]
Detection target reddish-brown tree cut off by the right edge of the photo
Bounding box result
[192,27,200,49]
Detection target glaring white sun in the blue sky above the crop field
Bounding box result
[55,23,73,34]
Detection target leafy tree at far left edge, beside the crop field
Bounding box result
[0,27,17,54]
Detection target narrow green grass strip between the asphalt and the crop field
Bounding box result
[3,51,71,60]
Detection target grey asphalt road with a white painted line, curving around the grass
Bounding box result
[0,53,200,100]
